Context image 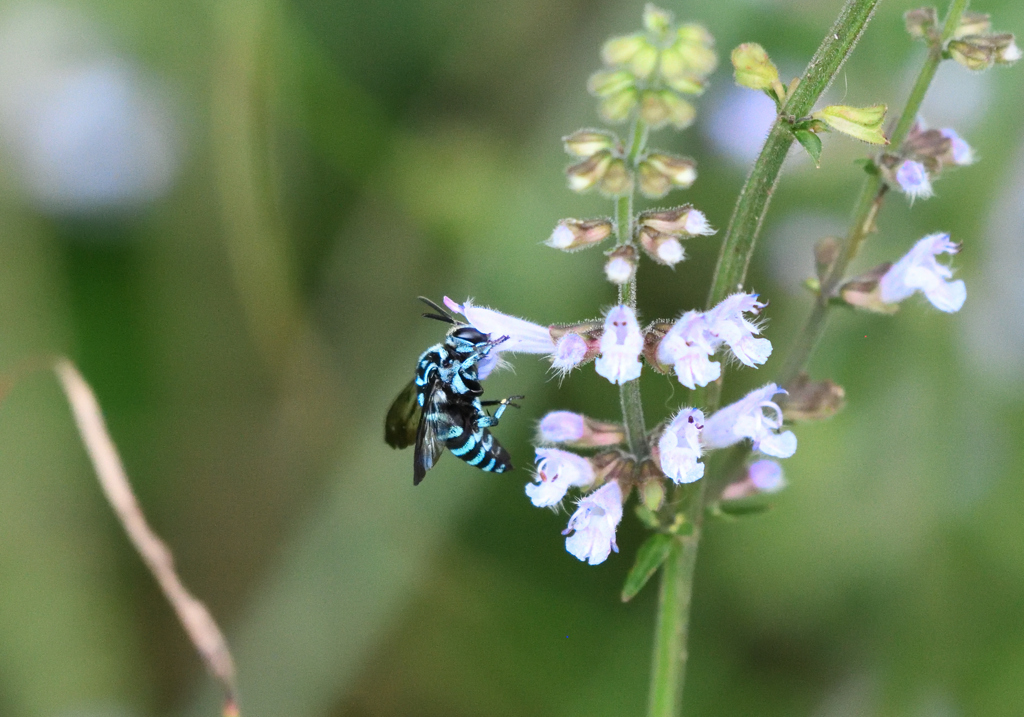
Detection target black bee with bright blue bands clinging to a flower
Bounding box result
[384,296,523,486]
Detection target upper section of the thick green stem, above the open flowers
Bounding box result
[708,0,880,308]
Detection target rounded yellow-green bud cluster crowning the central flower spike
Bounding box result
[588,4,718,129]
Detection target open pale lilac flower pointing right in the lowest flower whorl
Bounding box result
[700,383,797,458]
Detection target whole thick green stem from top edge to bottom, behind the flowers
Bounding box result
[647,0,880,717]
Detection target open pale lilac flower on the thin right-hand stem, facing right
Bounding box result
[879,234,967,313]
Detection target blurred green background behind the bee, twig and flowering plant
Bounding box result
[0,0,1024,717]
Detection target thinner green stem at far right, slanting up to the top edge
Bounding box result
[777,0,968,386]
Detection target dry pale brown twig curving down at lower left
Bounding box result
[52,359,239,717]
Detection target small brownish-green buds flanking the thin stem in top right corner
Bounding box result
[903,7,1022,72]
